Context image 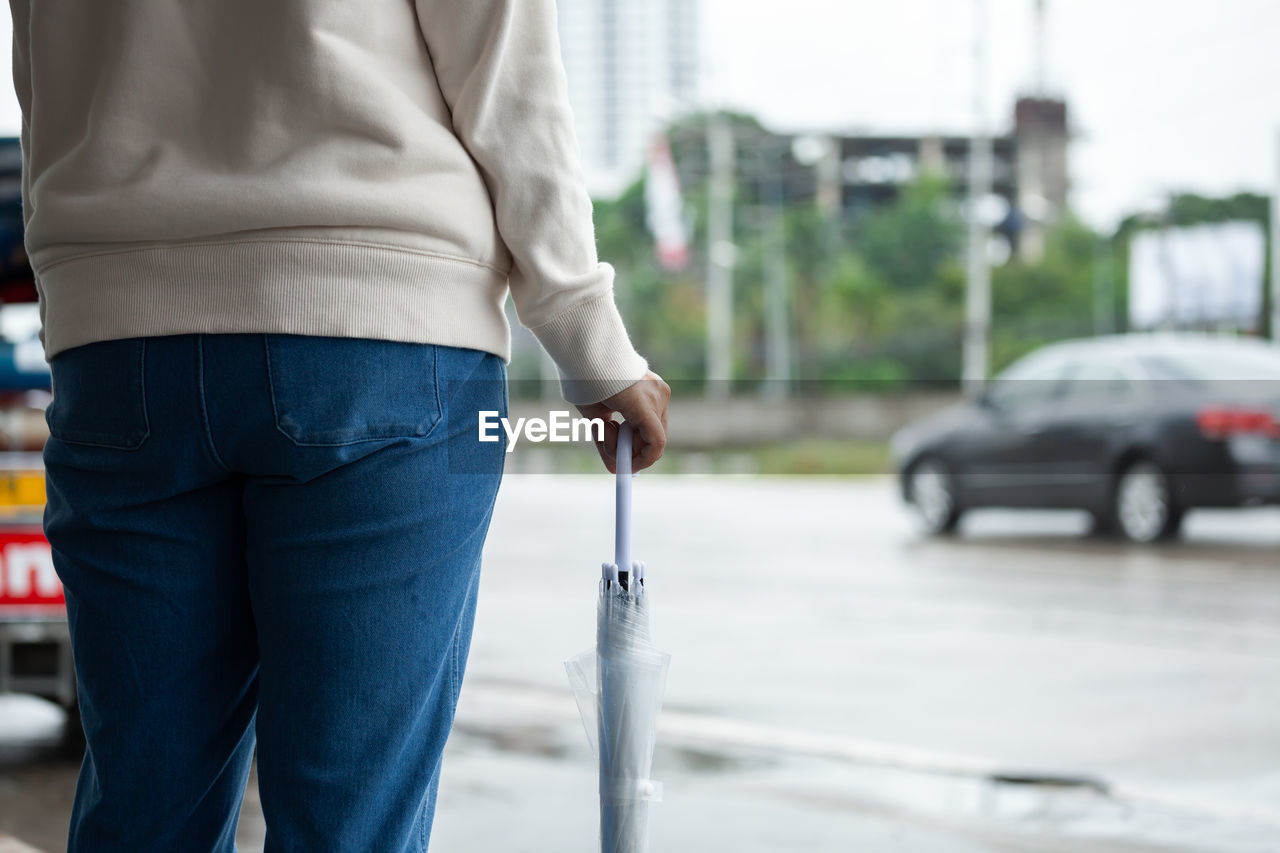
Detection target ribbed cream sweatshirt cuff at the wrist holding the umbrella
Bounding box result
[530,291,649,406]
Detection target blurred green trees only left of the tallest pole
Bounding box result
[595,167,964,392]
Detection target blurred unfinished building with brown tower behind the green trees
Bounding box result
[671,97,1071,261]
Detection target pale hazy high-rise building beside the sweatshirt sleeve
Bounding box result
[557,0,699,197]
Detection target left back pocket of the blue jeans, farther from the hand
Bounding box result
[45,338,151,450]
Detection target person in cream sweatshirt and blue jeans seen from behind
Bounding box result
[10,0,669,853]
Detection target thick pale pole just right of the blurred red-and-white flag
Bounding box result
[707,111,736,400]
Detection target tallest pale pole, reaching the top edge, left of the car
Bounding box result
[963,0,993,393]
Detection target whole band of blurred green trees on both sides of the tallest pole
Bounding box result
[595,117,1267,393]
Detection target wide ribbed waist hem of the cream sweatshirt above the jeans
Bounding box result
[37,240,511,361]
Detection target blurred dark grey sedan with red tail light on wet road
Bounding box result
[892,334,1280,542]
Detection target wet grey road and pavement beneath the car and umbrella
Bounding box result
[0,475,1280,853]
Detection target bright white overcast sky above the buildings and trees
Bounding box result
[0,0,1280,225]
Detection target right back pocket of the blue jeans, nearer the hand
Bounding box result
[264,334,440,447]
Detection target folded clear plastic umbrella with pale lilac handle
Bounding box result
[564,424,671,853]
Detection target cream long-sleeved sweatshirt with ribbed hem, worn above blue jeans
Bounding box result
[10,0,646,402]
